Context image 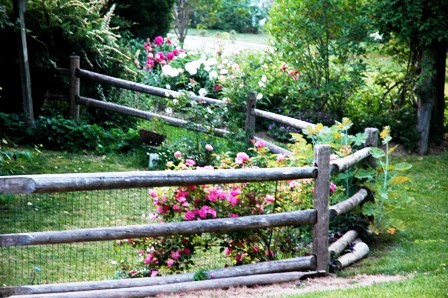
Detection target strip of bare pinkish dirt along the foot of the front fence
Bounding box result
[158,274,407,298]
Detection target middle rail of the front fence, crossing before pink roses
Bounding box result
[0,210,316,247]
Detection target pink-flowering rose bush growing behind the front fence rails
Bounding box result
[116,134,343,276]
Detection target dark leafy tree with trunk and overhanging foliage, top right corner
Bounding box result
[375,0,448,154]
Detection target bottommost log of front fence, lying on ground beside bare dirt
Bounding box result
[9,271,317,298]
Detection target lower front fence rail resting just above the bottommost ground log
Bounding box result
[0,256,316,297]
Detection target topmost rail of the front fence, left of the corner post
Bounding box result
[0,167,317,194]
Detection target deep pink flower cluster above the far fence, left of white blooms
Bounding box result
[143,36,185,71]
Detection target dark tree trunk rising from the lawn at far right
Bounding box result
[415,43,437,155]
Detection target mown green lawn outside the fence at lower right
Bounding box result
[290,153,448,297]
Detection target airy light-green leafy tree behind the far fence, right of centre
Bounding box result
[269,0,369,117]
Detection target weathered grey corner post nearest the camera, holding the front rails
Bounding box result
[313,145,331,273]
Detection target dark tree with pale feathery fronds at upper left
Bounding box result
[0,0,129,115]
